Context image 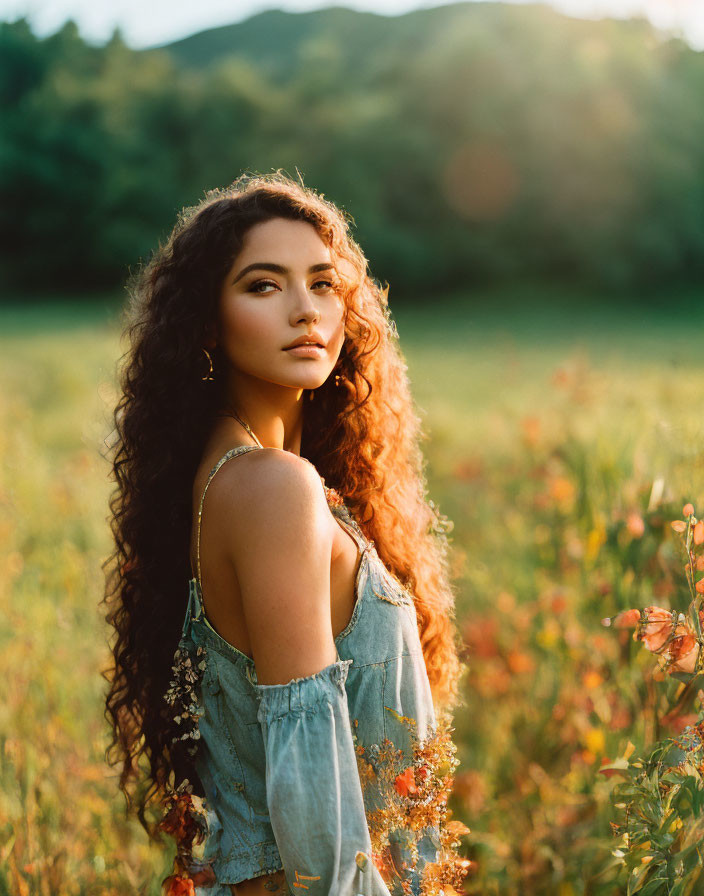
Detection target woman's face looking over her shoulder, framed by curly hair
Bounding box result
[218,218,345,389]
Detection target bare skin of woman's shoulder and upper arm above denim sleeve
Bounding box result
[226,448,337,684]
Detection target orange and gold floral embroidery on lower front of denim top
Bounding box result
[353,706,471,896]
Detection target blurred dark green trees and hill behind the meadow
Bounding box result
[0,3,704,298]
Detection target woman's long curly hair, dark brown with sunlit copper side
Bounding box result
[101,169,462,839]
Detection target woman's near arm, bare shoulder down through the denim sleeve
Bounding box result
[223,449,389,896]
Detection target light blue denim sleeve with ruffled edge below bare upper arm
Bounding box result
[255,659,390,896]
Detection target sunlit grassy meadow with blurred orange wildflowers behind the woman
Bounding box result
[0,289,704,896]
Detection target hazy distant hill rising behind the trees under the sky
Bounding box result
[152,2,652,85]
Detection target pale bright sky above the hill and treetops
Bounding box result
[0,0,704,50]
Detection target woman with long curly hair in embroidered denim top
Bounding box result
[106,172,469,896]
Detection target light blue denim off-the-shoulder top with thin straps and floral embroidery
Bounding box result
[167,445,468,896]
